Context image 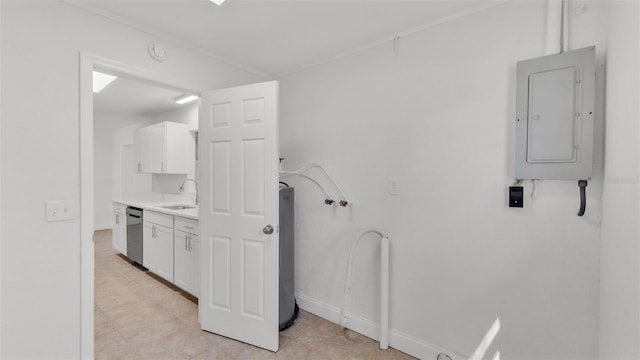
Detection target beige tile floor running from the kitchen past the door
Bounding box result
[94,230,412,360]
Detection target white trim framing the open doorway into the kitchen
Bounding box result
[79,52,200,359]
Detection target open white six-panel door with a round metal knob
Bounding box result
[198,81,279,351]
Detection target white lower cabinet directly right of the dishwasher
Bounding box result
[142,211,173,282]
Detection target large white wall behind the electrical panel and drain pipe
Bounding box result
[280,1,603,359]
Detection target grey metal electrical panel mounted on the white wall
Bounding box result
[515,47,595,180]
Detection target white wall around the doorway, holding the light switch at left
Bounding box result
[0,1,263,358]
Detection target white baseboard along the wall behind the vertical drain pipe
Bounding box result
[296,293,468,359]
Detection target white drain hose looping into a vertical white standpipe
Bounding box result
[340,229,389,350]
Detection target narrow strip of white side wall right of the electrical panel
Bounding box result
[600,1,640,359]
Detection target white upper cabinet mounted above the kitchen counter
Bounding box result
[134,121,195,174]
